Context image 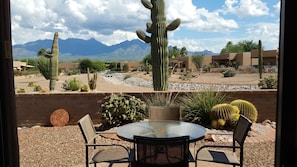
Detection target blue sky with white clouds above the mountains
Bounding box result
[11,0,280,53]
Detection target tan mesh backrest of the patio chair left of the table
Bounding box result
[78,114,96,143]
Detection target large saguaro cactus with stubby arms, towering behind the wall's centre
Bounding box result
[136,0,181,91]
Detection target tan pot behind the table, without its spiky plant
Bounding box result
[148,106,180,120]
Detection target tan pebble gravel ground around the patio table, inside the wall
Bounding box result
[18,125,275,167]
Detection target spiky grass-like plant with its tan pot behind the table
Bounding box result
[144,92,181,120]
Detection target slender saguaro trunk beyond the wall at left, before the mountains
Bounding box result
[49,32,59,90]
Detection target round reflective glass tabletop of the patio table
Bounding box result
[117,120,206,142]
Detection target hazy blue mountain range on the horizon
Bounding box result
[12,38,216,61]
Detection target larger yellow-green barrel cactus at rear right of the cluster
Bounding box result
[230,99,258,122]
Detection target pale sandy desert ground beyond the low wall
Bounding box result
[14,71,277,93]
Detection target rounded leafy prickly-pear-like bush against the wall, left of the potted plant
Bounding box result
[101,94,148,128]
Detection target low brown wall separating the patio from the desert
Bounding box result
[16,90,277,127]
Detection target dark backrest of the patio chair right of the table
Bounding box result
[233,115,252,145]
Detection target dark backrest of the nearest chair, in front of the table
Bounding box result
[134,136,189,167]
